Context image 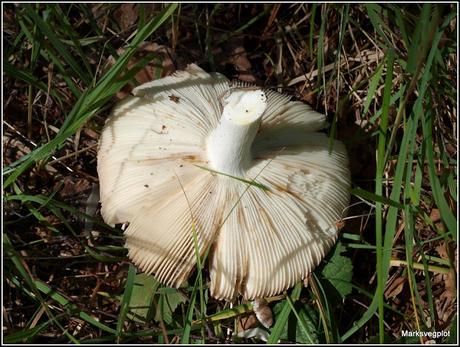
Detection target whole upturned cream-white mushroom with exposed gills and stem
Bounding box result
[98,64,350,300]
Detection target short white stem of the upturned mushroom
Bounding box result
[207,89,267,176]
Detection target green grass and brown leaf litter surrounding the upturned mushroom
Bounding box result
[2,3,458,344]
